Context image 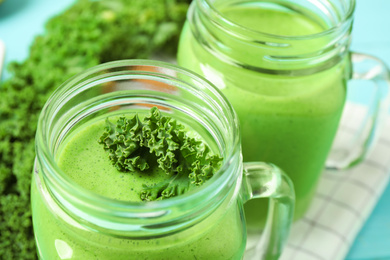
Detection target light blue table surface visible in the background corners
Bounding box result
[0,0,390,260]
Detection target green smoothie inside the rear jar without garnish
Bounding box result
[178,1,348,225]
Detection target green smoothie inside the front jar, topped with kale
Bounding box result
[32,113,245,260]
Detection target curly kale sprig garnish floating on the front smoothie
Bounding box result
[99,107,222,201]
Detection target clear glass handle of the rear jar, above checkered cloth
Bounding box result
[326,53,390,169]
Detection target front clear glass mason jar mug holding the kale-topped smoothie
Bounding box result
[31,60,294,260]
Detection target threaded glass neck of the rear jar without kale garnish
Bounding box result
[188,0,355,75]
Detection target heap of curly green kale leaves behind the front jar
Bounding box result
[0,0,190,260]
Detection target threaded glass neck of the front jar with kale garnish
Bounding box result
[36,60,242,238]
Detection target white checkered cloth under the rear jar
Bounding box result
[280,102,390,260]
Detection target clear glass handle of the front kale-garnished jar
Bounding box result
[242,162,295,260]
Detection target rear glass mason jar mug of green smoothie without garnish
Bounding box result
[177,0,389,223]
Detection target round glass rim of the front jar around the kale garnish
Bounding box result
[36,60,241,232]
